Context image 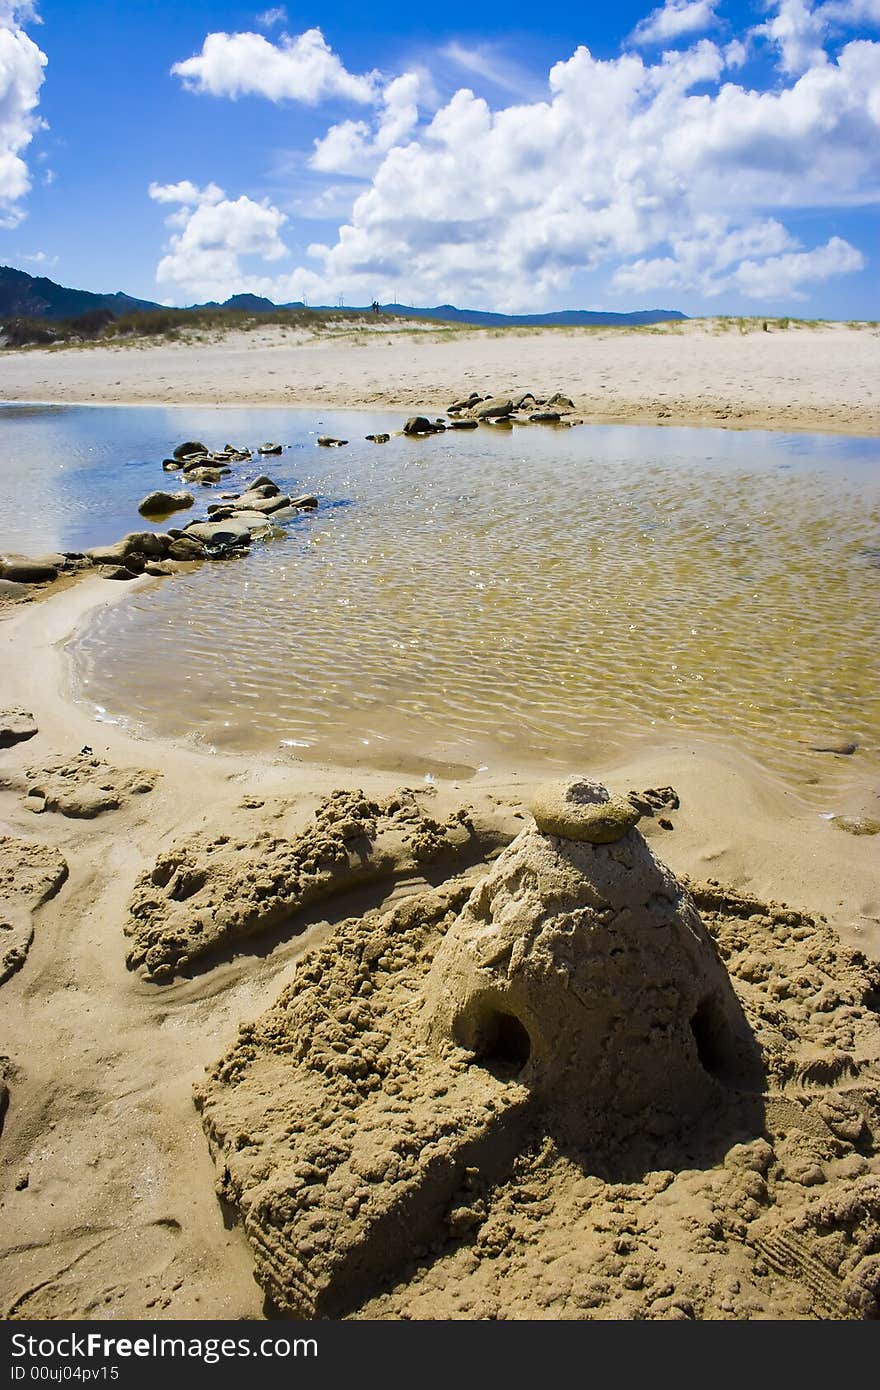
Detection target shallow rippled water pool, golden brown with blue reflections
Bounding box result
[0,409,880,781]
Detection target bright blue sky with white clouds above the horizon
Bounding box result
[0,0,880,318]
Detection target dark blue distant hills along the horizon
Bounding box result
[0,265,687,328]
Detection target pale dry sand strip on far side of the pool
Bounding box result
[0,320,880,434]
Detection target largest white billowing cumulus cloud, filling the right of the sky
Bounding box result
[298,40,880,309]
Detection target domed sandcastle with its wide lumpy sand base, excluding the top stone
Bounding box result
[196,783,880,1318]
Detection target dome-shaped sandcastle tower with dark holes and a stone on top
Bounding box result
[425,777,749,1129]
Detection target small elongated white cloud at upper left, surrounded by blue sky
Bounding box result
[171,29,378,106]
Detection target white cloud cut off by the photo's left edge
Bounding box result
[0,0,47,227]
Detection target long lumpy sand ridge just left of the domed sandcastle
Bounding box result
[125,791,510,980]
